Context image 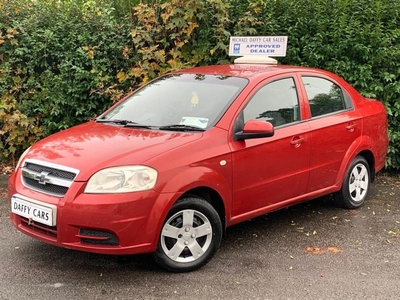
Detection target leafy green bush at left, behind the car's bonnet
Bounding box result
[0,0,131,157]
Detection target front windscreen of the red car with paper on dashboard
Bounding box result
[97,74,248,130]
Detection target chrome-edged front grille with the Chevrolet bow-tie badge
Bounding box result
[22,159,79,197]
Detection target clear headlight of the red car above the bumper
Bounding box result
[85,166,158,194]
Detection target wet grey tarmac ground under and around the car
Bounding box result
[0,175,400,300]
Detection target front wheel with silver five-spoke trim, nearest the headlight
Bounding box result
[154,197,222,272]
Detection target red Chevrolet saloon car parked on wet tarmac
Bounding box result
[8,59,388,272]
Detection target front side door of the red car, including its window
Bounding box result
[230,77,311,220]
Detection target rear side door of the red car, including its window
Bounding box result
[301,74,362,193]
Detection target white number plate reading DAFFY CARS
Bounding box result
[11,195,57,226]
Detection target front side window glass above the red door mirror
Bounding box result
[243,78,300,126]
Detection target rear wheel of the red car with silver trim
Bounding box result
[334,156,371,209]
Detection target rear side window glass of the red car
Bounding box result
[302,76,346,117]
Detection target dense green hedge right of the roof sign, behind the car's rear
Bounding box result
[231,0,400,170]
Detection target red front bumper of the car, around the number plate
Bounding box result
[8,171,174,255]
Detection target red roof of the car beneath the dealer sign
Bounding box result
[174,64,328,78]
